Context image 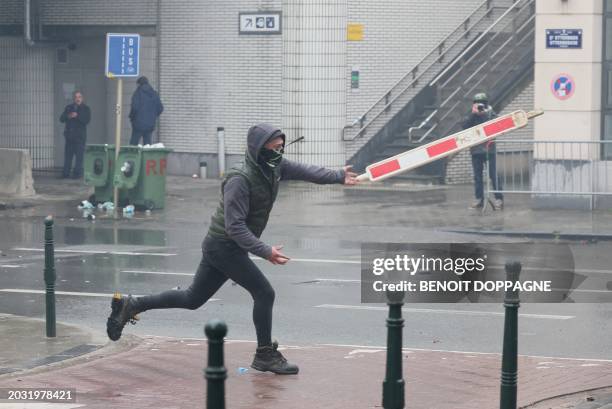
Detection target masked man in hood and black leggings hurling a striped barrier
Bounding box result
[107,124,357,374]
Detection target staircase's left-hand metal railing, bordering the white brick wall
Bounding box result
[343,0,506,140]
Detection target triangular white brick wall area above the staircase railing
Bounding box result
[346,0,482,122]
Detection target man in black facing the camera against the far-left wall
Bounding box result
[60,91,91,179]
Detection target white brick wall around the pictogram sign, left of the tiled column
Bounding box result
[160,0,282,161]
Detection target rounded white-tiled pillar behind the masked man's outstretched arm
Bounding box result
[282,0,347,167]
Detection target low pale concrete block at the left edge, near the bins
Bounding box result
[0,149,35,197]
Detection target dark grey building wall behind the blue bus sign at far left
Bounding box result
[0,0,158,169]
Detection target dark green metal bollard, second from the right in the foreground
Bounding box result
[382,293,404,409]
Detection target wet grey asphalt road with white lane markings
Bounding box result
[0,180,612,359]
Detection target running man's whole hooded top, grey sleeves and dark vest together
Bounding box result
[208,124,345,259]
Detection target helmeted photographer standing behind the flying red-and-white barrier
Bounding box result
[462,92,504,210]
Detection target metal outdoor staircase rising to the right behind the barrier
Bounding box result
[343,0,535,183]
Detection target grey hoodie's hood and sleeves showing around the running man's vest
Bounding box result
[223,124,345,259]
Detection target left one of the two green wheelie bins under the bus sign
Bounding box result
[83,145,115,205]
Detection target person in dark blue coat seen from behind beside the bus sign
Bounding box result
[129,76,164,145]
